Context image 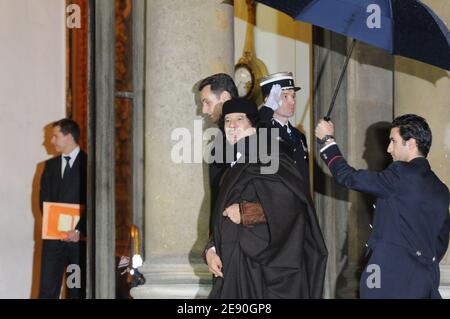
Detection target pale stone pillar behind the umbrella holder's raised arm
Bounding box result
[344,40,394,298]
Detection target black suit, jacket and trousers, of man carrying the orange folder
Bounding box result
[39,150,87,299]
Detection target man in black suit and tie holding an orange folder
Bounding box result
[39,119,87,299]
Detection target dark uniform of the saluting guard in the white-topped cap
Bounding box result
[259,106,311,194]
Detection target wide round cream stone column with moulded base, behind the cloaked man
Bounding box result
[132,0,234,298]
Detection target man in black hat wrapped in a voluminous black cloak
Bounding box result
[206,99,327,299]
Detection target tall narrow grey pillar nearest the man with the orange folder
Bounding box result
[87,1,116,299]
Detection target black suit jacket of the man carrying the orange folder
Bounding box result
[39,150,87,234]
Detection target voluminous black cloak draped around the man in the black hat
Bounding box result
[209,137,328,299]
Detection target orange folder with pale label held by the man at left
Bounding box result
[42,202,81,240]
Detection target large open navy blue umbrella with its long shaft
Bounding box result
[256,0,450,118]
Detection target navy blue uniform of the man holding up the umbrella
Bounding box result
[321,145,450,298]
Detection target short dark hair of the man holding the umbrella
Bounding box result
[392,114,432,157]
